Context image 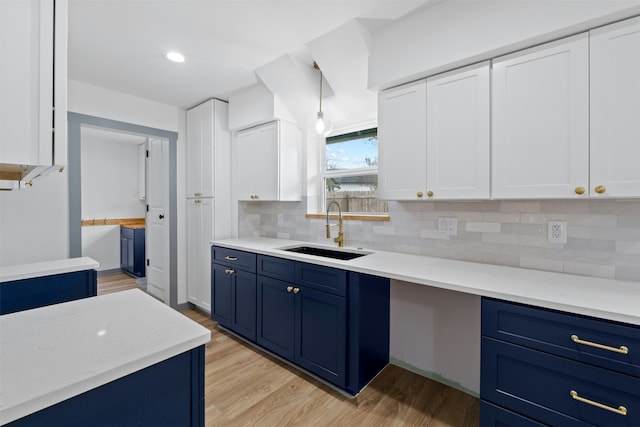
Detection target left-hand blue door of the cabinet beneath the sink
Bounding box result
[256,276,295,360]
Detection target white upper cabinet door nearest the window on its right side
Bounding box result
[378,81,427,200]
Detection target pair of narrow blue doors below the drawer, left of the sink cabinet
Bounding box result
[211,263,256,341]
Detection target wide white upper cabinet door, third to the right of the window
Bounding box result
[492,34,589,199]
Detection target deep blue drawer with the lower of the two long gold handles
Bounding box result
[480,337,640,427]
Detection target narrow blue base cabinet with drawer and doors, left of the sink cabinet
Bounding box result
[211,246,256,341]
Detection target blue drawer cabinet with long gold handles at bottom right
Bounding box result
[480,298,640,427]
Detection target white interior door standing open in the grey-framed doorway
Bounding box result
[146,138,170,303]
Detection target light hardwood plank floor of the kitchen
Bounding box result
[98,274,480,427]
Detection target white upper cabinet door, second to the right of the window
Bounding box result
[426,62,491,200]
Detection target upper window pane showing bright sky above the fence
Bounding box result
[325,134,378,170]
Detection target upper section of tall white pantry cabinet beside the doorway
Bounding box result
[187,99,231,197]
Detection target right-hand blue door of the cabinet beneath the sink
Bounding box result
[294,287,347,388]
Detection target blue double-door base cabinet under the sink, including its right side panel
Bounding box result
[256,255,389,395]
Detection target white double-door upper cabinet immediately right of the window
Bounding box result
[378,63,490,200]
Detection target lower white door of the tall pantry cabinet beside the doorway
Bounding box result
[187,198,214,312]
